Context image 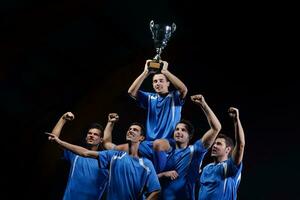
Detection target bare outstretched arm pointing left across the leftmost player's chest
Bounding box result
[46,133,98,159]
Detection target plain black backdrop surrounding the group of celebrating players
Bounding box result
[0,0,300,200]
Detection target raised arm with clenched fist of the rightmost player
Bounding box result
[228,107,245,165]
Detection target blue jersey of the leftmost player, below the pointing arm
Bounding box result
[63,150,108,200]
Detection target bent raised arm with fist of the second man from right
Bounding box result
[191,94,222,148]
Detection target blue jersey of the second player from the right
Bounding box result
[160,140,207,200]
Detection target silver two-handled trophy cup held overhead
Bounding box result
[148,20,176,71]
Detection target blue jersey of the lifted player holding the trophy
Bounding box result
[137,90,184,140]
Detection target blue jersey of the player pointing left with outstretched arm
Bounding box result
[98,150,160,200]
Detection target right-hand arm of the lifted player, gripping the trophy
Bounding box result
[161,60,188,99]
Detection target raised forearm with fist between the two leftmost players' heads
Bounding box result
[103,113,119,149]
